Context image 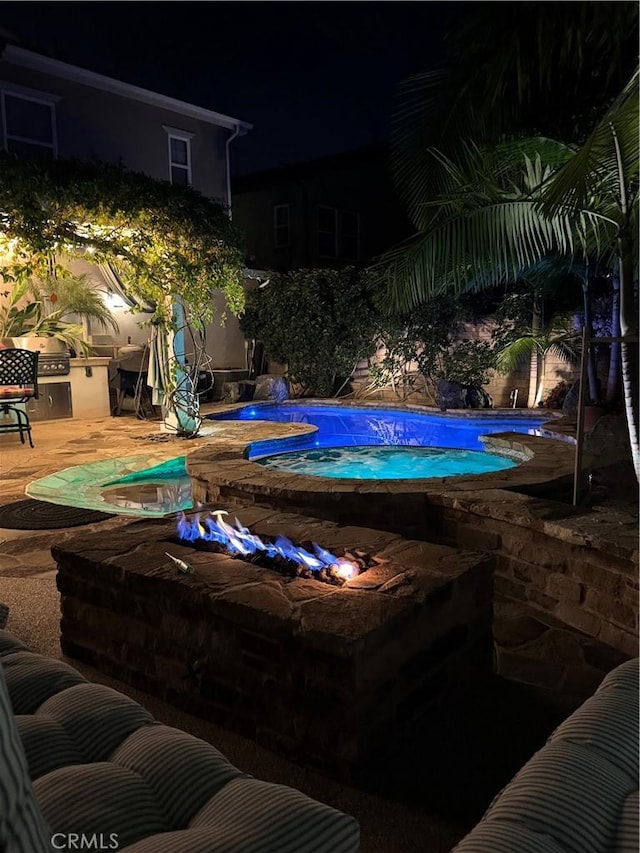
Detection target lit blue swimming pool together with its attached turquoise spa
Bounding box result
[210,402,549,479]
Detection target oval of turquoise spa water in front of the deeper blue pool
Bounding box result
[255,446,517,480]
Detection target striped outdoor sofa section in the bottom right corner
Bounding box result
[452,658,640,853]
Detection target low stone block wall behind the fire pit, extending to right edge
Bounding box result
[194,480,639,656]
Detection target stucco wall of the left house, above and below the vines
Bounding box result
[0,52,252,376]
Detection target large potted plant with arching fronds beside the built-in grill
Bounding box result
[0,273,118,356]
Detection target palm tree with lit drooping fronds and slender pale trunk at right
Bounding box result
[378,71,640,480]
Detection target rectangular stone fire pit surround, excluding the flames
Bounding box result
[52,507,492,778]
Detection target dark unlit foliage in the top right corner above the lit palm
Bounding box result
[392,2,638,229]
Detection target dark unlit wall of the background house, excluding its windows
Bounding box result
[232,147,410,272]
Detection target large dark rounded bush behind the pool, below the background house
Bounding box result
[240,267,380,397]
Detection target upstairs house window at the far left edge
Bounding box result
[2,92,57,160]
